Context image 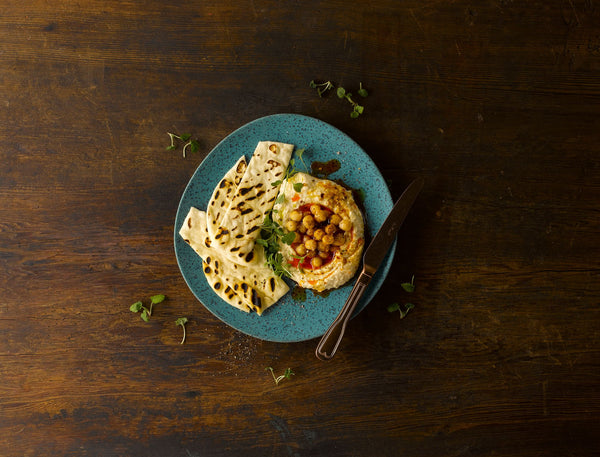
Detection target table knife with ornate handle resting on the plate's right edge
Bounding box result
[315,178,424,360]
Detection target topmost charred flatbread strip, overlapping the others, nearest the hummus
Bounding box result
[212,141,294,264]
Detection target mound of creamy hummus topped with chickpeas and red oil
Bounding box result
[272,173,365,292]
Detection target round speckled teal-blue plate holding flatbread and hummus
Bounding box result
[174,114,396,342]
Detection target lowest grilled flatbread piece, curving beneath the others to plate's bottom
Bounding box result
[179,207,289,315]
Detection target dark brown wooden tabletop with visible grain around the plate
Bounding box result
[0,0,600,457]
